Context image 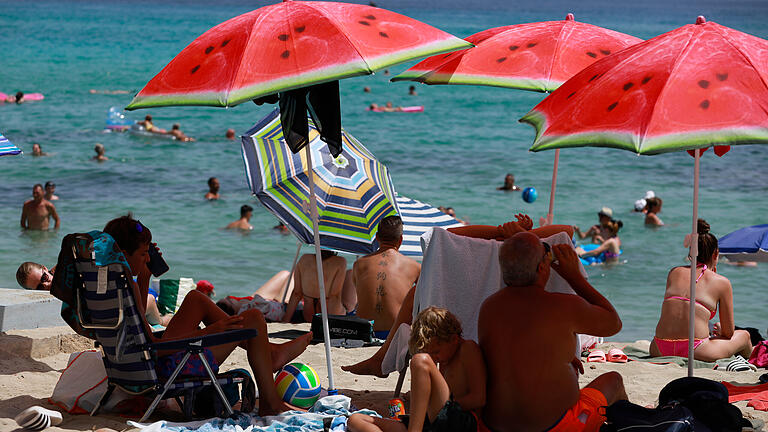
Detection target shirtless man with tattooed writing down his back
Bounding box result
[352,216,421,339]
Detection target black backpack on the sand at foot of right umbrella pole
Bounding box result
[600,377,751,432]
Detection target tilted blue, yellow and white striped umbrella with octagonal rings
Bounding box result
[242,110,398,254]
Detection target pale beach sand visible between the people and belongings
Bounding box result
[0,324,768,431]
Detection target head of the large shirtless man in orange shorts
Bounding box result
[499,235,542,287]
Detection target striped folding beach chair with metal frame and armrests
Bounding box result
[56,231,256,422]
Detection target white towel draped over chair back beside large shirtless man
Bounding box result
[413,228,587,341]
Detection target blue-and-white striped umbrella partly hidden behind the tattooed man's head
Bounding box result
[397,195,462,258]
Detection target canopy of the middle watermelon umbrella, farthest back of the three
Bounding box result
[392,14,642,92]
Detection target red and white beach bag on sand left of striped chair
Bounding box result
[48,350,107,414]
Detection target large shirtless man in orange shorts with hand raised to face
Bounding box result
[478,233,627,431]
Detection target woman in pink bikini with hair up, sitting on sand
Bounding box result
[650,219,752,361]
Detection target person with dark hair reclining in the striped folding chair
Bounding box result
[104,215,312,416]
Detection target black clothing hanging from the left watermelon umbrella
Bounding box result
[253,81,341,157]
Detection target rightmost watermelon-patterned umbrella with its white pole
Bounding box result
[520,16,768,375]
